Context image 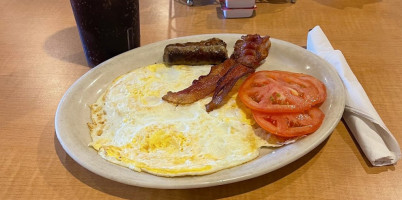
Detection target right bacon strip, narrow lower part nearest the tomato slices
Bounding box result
[205,63,255,112]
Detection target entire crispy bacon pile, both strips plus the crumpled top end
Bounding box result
[162,34,271,112]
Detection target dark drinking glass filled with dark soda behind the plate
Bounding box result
[70,0,140,67]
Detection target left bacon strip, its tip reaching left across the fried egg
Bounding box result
[162,59,235,104]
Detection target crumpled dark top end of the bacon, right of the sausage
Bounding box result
[230,34,271,69]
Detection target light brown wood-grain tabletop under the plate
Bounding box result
[0,0,402,200]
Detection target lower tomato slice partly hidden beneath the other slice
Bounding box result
[252,107,325,138]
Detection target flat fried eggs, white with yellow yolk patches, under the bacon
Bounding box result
[88,64,280,177]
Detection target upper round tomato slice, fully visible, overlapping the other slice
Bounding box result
[239,71,326,113]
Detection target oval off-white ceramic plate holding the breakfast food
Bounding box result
[55,34,345,189]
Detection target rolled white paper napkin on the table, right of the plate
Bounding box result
[307,26,401,166]
